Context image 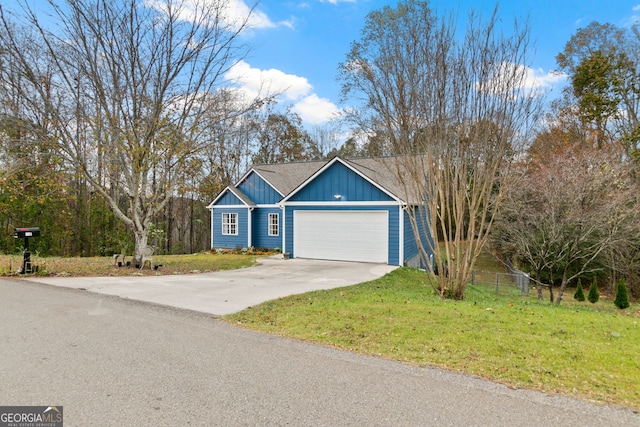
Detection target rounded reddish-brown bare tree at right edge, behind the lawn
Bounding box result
[495,145,639,304]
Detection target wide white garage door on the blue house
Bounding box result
[293,211,389,264]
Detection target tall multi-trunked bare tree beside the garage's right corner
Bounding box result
[339,0,540,299]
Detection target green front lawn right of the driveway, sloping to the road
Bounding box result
[225,268,640,409]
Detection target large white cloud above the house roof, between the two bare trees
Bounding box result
[225,61,339,125]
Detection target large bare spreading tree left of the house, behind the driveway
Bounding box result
[0,0,264,263]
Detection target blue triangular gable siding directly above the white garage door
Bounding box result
[290,162,393,202]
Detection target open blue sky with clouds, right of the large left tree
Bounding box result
[232,0,640,126]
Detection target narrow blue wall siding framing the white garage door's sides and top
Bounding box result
[285,205,400,265]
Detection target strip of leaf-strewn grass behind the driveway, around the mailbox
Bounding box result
[0,252,258,276]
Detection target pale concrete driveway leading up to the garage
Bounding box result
[24,256,397,315]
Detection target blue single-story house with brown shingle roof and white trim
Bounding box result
[208,157,429,266]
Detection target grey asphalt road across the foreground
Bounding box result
[0,280,640,427]
